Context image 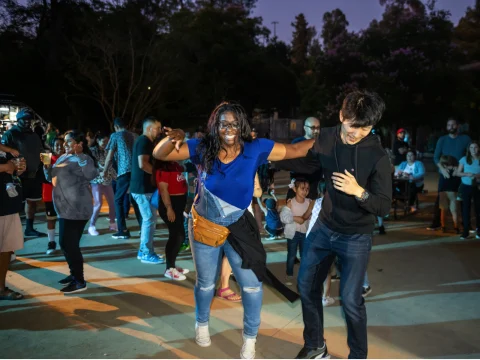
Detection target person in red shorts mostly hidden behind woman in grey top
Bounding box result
[42,138,65,255]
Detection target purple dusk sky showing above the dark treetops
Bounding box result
[254,0,475,43]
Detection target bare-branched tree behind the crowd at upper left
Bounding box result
[67,2,172,126]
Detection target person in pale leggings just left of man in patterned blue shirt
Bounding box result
[88,132,118,236]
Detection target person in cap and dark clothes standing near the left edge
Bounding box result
[2,108,47,237]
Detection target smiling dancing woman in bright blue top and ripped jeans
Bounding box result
[153,103,314,359]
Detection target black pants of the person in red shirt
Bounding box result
[158,194,187,269]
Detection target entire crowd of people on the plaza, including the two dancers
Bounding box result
[0,91,480,359]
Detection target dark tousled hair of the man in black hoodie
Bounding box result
[341,90,385,128]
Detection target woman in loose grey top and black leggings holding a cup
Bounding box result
[42,130,98,294]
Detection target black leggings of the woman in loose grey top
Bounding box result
[58,218,88,283]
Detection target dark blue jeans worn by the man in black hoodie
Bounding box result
[298,221,372,359]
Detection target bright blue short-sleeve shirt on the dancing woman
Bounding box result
[187,139,274,209]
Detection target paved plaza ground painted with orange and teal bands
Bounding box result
[0,173,480,358]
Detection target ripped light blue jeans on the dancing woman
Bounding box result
[191,233,263,338]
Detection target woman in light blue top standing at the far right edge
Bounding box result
[456,141,480,240]
